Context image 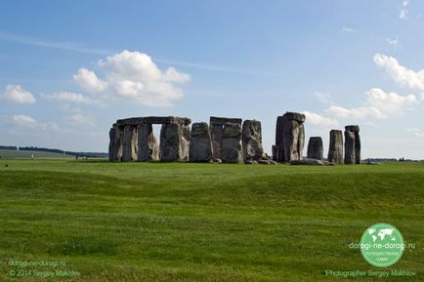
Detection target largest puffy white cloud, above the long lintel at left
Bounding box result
[73,50,190,107]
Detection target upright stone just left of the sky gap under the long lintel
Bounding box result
[137,123,159,162]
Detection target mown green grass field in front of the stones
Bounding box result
[0,159,424,282]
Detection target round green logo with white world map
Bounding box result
[360,223,405,267]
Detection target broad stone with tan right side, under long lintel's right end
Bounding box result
[160,123,190,162]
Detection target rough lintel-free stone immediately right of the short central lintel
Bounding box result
[242,120,264,159]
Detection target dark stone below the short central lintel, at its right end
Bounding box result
[221,123,243,163]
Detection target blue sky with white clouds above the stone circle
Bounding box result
[0,0,424,159]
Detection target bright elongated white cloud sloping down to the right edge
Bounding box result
[373,53,424,90]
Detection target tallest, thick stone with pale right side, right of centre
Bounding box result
[273,112,306,162]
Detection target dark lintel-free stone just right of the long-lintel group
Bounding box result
[189,122,213,162]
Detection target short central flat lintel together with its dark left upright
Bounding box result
[209,116,242,159]
